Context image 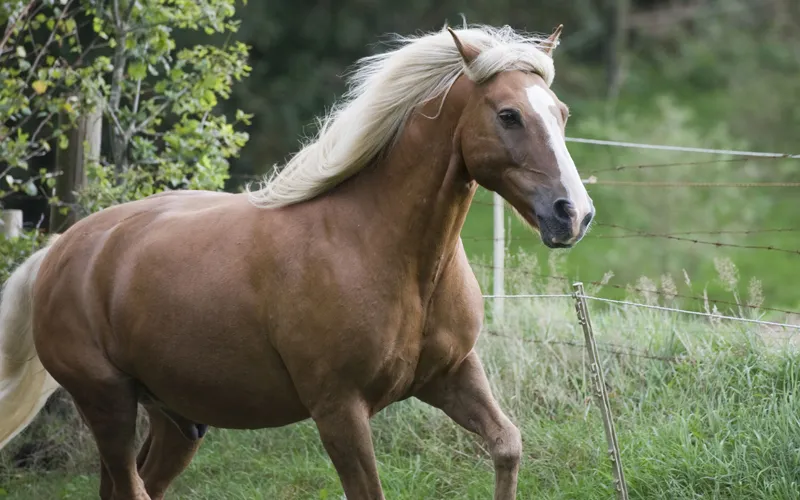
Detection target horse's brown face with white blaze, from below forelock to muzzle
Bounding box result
[460,71,594,248]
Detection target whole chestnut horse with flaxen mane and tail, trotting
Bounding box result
[0,27,594,500]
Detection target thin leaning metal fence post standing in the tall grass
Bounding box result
[572,283,628,500]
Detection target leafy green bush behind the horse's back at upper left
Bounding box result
[0,0,250,211]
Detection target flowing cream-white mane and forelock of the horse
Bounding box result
[248,26,555,208]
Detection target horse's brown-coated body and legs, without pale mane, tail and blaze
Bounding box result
[0,25,588,500]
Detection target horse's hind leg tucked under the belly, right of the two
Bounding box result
[137,406,207,500]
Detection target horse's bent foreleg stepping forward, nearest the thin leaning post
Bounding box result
[416,351,522,500]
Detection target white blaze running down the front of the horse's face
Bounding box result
[525,85,592,232]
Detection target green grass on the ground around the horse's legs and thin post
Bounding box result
[0,259,800,500]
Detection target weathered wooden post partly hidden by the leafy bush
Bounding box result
[50,105,103,233]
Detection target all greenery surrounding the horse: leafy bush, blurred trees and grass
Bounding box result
[0,0,800,499]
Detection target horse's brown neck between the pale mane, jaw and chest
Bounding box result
[336,78,477,294]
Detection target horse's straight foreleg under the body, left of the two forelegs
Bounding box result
[314,404,384,500]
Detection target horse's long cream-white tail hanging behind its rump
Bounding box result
[0,238,59,449]
